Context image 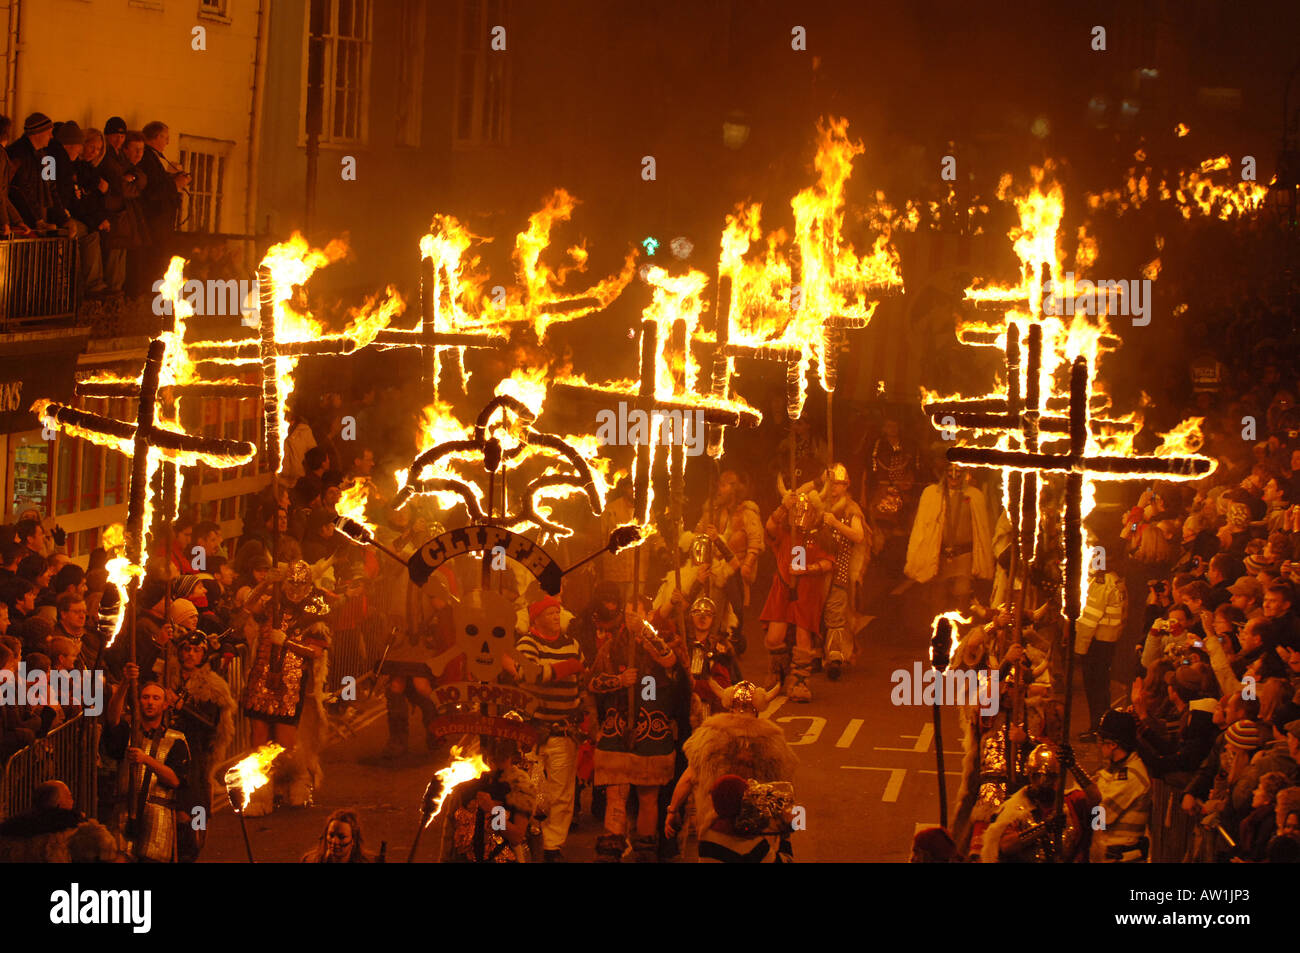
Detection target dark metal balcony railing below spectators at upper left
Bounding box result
[0,237,82,332]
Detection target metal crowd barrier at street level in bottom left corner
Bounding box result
[0,712,100,818]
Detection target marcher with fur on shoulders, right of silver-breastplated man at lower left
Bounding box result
[172,629,235,863]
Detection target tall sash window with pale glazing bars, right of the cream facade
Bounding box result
[303,0,371,144]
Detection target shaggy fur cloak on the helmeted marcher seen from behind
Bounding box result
[681,711,798,831]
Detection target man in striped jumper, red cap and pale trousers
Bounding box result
[515,595,582,863]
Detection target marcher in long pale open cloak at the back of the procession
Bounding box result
[904,464,993,621]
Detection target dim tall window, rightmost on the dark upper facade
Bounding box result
[452,0,510,147]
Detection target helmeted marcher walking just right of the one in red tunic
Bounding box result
[822,463,871,681]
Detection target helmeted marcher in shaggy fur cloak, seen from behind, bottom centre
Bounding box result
[664,681,798,863]
